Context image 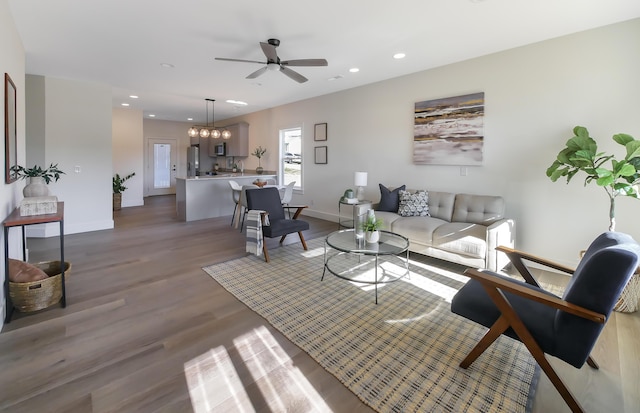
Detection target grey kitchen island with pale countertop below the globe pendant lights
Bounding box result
[176,172,277,221]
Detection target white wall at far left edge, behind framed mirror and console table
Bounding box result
[0,0,25,329]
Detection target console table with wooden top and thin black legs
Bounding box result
[2,202,67,323]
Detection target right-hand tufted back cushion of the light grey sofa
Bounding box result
[451,194,505,226]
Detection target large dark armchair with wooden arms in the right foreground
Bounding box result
[451,232,640,412]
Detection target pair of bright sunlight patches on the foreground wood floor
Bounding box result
[184,326,331,413]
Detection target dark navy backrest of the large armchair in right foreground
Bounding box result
[554,232,640,365]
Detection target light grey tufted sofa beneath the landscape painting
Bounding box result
[374,189,515,271]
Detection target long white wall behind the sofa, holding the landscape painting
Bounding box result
[219,19,640,265]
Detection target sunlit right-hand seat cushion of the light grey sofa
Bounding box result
[431,222,487,258]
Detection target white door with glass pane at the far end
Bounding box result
[147,138,178,196]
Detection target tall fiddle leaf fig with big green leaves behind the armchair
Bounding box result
[547,126,640,231]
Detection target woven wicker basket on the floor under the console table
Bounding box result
[9,261,71,312]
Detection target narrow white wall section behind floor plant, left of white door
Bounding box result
[112,108,144,207]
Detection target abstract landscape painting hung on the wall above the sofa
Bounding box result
[413,92,484,165]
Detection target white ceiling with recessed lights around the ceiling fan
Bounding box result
[8,0,640,124]
